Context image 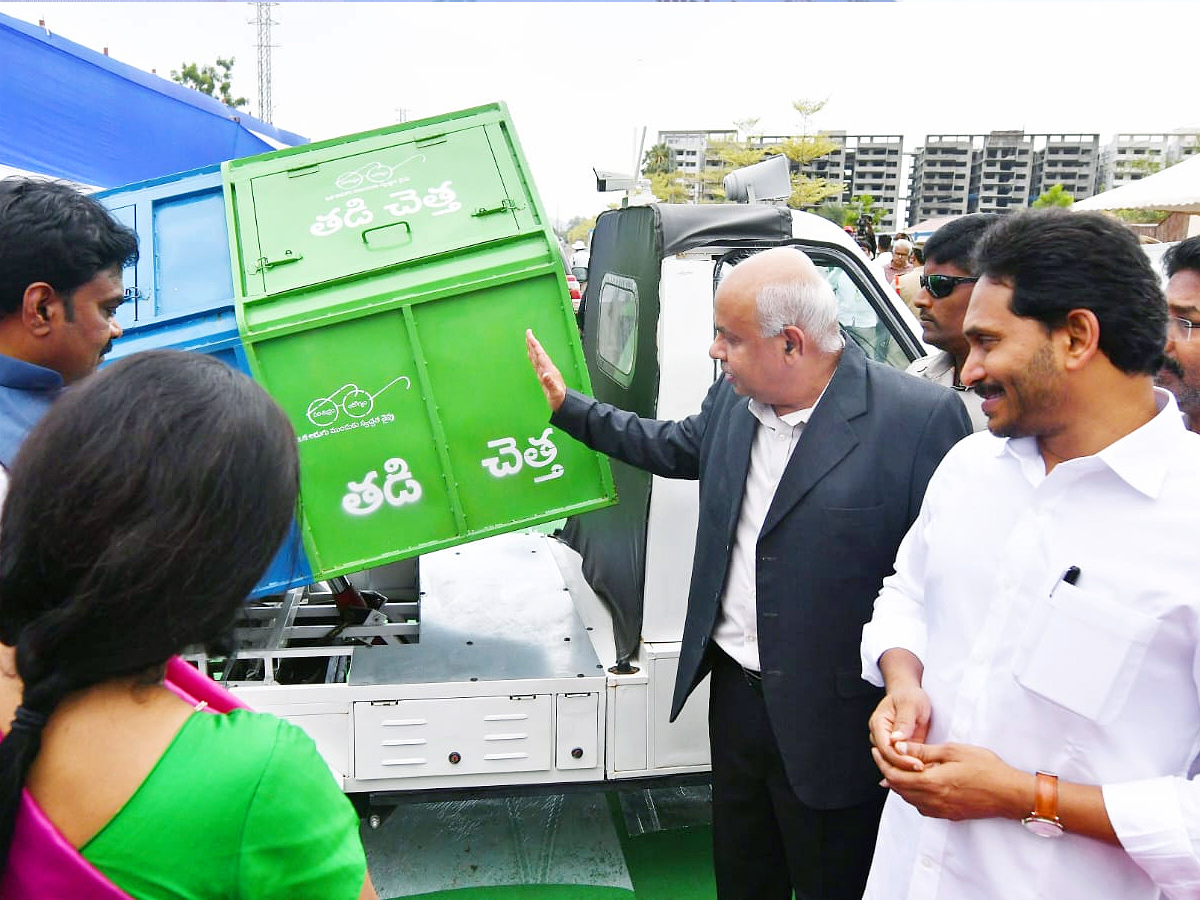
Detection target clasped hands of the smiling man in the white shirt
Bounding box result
[870,685,1027,821]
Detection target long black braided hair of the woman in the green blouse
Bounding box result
[0,350,299,862]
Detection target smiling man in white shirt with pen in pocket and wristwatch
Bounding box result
[862,211,1200,900]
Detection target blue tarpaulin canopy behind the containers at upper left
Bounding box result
[0,14,307,187]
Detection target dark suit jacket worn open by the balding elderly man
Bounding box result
[551,342,971,809]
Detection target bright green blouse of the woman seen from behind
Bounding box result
[82,709,366,900]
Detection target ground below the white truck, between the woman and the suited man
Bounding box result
[364,787,715,900]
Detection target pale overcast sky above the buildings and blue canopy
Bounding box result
[0,0,1200,221]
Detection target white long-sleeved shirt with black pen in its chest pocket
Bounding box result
[863,390,1200,900]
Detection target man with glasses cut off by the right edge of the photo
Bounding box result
[1156,238,1200,432]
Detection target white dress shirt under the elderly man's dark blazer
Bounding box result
[713,391,824,672]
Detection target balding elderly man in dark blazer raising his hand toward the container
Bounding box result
[526,247,971,900]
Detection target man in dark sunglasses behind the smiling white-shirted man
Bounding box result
[908,212,1000,431]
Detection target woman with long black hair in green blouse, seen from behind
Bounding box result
[0,350,376,900]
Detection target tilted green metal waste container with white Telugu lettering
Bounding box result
[222,104,616,578]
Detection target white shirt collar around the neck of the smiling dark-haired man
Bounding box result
[996,388,1187,499]
